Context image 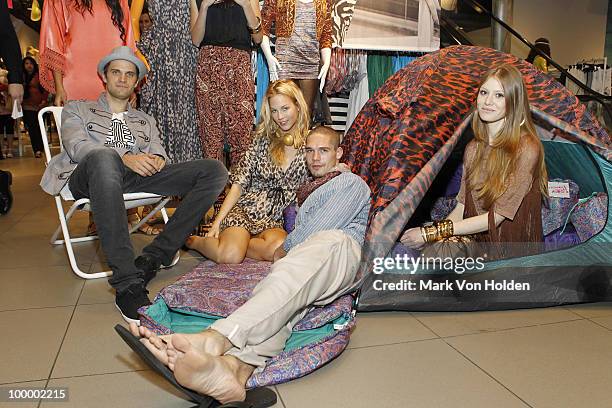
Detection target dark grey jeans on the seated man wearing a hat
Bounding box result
[69,147,227,291]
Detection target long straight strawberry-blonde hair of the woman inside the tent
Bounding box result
[467,64,548,209]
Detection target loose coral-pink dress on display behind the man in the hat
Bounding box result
[40,0,136,100]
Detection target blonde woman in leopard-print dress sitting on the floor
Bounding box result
[186,80,310,264]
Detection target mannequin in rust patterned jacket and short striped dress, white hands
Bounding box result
[261,0,333,113]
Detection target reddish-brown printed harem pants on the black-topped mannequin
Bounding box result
[196,45,255,166]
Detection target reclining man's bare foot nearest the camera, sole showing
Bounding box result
[172,336,254,404]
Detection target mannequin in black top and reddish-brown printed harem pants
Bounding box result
[191,0,262,166]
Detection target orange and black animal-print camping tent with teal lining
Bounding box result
[343,46,612,310]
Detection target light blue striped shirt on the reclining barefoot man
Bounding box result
[283,172,371,252]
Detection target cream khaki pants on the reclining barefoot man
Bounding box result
[211,230,361,370]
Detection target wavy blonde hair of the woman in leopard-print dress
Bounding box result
[255,79,310,166]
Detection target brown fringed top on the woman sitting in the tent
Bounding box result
[457,137,542,259]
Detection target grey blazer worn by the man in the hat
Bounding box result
[40,92,170,195]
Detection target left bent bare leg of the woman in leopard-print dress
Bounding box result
[185,227,251,264]
